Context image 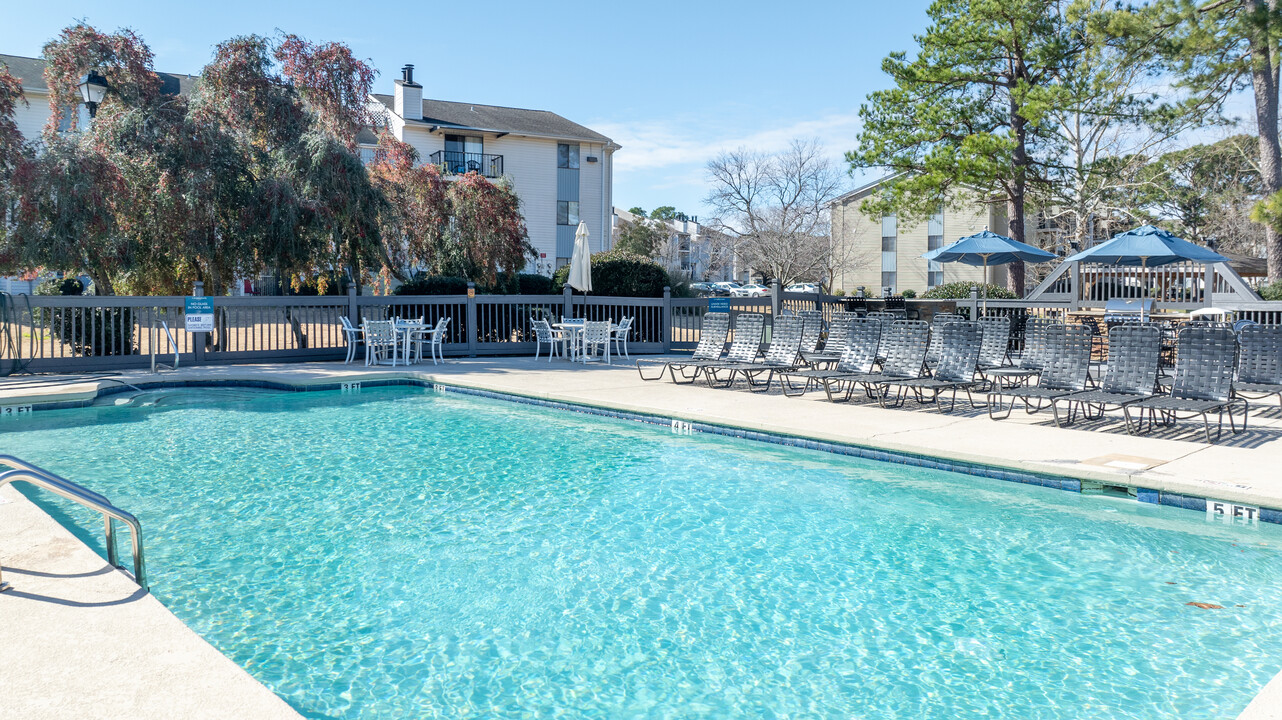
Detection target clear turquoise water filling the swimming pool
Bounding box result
[0,388,1282,720]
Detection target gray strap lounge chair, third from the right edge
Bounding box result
[1051,323,1161,433]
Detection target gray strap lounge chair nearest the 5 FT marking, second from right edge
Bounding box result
[1122,325,1250,443]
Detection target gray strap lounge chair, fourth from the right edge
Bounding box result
[988,320,1091,425]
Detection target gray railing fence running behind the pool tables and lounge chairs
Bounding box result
[0,280,1282,372]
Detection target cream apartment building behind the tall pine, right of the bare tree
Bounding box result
[828,178,1006,296]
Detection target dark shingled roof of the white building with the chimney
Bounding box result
[373,94,610,142]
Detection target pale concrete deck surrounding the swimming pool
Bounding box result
[0,357,1282,720]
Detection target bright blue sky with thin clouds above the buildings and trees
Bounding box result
[0,0,928,215]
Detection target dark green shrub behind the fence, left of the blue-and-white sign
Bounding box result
[31,278,135,357]
